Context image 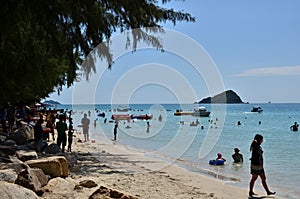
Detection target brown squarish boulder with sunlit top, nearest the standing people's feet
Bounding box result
[25,156,69,177]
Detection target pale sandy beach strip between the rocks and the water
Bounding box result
[55,131,279,199]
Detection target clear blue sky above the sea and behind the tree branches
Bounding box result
[47,0,300,104]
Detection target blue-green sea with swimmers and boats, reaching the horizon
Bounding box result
[56,103,300,199]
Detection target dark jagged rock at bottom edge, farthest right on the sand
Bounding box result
[89,186,138,199]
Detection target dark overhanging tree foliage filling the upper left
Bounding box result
[0,0,194,104]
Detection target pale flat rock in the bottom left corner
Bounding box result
[0,181,39,199]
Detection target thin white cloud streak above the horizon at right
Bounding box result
[235,66,300,77]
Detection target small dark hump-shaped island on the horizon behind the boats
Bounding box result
[196,90,244,104]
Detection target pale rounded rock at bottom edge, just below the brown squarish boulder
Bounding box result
[42,178,77,198]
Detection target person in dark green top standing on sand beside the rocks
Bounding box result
[56,115,68,153]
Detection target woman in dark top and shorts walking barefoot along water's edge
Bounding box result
[249,134,276,197]
